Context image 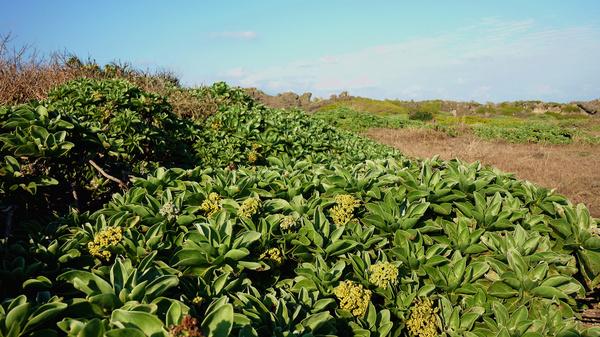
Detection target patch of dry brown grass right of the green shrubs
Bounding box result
[365,129,600,217]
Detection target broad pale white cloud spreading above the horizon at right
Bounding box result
[218,18,600,101]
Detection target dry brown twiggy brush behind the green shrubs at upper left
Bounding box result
[0,35,227,119]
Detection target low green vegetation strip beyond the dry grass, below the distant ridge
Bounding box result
[313,103,600,144]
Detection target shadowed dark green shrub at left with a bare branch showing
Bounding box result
[0,79,195,214]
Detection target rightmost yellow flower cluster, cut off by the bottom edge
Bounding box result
[406,298,440,337]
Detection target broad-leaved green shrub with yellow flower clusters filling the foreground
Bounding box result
[1,157,600,336]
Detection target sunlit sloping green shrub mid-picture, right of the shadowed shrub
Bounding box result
[195,106,400,167]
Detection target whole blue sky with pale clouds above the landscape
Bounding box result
[0,0,600,102]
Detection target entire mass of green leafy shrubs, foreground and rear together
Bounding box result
[0,80,600,337]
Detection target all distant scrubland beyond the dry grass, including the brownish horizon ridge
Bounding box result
[245,88,600,144]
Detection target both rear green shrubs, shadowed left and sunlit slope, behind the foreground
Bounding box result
[0,79,392,217]
